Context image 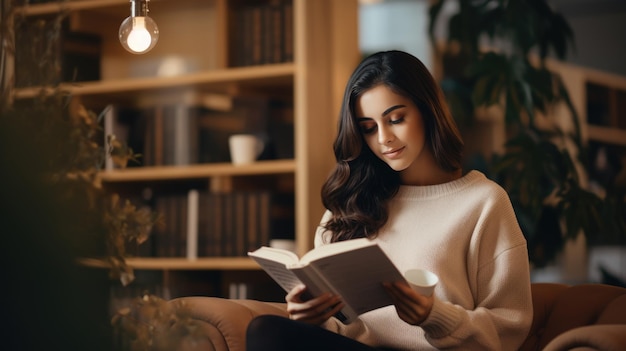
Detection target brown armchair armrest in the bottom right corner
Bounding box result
[543,324,626,351]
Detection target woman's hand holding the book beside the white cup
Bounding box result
[383,281,434,325]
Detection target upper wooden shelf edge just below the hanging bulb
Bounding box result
[14,62,295,99]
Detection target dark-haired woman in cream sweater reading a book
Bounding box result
[247,51,532,351]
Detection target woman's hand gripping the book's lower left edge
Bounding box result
[285,285,344,325]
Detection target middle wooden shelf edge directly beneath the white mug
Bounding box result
[100,160,296,183]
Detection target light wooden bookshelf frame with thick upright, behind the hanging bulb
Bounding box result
[8,0,360,300]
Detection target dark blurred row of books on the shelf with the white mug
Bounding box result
[104,97,294,170]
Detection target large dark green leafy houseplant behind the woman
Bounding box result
[429,0,626,266]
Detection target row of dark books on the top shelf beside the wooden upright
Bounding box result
[233,0,294,66]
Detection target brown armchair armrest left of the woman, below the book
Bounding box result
[170,297,287,351]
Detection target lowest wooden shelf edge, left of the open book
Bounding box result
[79,257,261,271]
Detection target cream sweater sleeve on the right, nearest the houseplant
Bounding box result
[421,194,533,350]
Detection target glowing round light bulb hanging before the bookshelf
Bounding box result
[119,0,159,54]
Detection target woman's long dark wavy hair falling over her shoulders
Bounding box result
[322,50,463,242]
